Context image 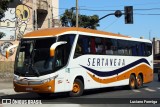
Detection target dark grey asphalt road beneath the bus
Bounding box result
[0,74,160,107]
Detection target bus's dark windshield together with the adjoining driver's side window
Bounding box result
[15,35,74,77]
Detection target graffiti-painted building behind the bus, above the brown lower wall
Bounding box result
[0,0,61,61]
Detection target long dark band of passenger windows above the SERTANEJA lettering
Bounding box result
[74,35,152,58]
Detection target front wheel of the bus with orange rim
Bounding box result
[69,79,84,97]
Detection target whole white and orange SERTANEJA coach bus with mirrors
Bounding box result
[6,27,153,97]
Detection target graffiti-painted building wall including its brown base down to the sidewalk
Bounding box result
[0,0,58,81]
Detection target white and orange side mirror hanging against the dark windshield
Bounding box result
[50,41,67,57]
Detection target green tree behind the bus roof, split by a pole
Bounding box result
[61,8,99,29]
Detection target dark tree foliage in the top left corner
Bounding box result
[0,0,14,20]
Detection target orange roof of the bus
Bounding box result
[24,27,130,38]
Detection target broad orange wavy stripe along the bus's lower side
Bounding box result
[88,64,153,84]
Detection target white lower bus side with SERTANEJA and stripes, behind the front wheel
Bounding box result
[73,55,153,89]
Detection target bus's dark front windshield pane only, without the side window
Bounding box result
[15,38,56,76]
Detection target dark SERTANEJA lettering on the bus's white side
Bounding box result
[87,58,125,66]
